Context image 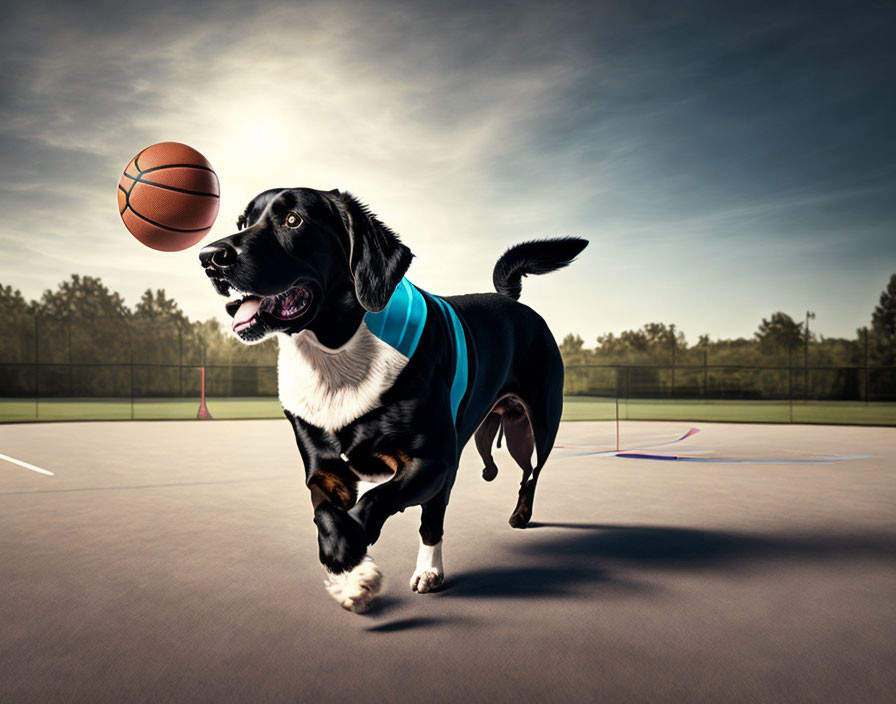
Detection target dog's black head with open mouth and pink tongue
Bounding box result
[199,188,413,343]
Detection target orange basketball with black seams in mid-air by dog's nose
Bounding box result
[118,142,220,252]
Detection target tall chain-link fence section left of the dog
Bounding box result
[0,313,282,422]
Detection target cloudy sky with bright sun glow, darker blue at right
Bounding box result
[0,0,896,347]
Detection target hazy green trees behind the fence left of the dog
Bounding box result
[0,274,277,397]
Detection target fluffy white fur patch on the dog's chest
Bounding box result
[277,321,408,432]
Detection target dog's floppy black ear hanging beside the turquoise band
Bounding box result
[334,193,414,312]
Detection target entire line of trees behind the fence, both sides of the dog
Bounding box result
[0,274,896,399]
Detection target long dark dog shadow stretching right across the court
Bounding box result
[443,522,896,598]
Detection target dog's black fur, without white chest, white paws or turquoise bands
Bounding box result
[200,188,587,573]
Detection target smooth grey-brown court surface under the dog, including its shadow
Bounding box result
[0,420,896,704]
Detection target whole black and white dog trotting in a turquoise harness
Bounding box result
[199,188,588,613]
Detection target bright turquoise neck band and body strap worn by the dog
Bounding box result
[364,278,469,423]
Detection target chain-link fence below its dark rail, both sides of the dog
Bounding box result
[0,362,896,425]
